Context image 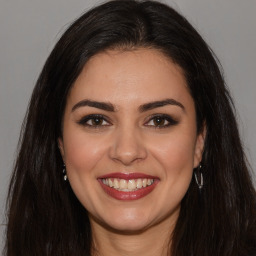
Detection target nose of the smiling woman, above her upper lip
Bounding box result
[110,128,147,166]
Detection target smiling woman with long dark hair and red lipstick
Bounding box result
[6,1,256,256]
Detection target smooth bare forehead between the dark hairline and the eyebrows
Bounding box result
[68,49,192,110]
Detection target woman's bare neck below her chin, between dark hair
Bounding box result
[91,214,175,256]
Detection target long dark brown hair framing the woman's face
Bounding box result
[5,0,256,256]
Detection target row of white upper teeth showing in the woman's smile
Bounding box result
[102,178,154,191]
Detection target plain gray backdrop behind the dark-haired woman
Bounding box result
[0,0,256,250]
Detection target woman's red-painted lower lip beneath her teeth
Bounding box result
[98,179,159,201]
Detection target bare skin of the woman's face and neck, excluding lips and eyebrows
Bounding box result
[59,49,204,256]
